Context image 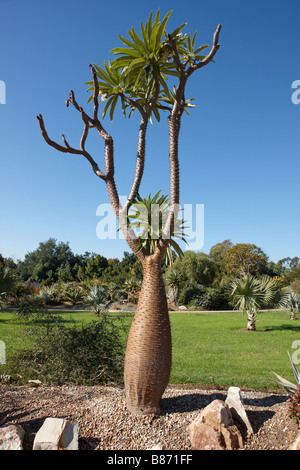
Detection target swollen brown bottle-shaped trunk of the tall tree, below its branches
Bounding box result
[124,256,172,414]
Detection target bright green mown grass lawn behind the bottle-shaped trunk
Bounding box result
[0,311,300,390]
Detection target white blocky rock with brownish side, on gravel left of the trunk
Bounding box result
[33,418,79,450]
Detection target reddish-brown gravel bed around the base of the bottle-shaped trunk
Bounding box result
[0,385,300,450]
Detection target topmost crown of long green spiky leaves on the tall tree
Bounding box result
[87,10,208,122]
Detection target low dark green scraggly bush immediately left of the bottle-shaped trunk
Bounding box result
[8,312,124,385]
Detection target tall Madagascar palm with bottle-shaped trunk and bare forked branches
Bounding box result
[38,10,221,413]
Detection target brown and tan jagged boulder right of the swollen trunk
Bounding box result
[188,400,243,450]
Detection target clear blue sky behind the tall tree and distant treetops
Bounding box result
[0,0,300,261]
